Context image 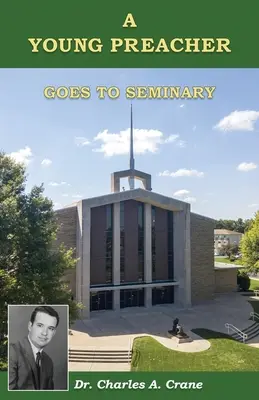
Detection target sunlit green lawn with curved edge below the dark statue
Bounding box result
[131,329,259,371]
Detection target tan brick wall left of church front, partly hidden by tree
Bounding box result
[54,207,77,298]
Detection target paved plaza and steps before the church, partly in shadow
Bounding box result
[69,293,259,371]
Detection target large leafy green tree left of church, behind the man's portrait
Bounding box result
[0,153,81,368]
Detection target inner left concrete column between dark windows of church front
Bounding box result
[112,202,120,311]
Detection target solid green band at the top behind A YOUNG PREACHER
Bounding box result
[0,0,259,68]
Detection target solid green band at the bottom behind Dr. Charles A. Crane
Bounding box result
[0,372,258,400]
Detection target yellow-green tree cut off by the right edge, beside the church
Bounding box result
[240,211,259,272]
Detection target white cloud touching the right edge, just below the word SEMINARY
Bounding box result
[215,110,259,131]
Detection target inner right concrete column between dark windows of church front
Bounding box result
[144,203,152,307]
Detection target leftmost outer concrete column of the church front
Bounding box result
[81,201,91,319]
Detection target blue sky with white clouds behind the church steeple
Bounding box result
[0,69,259,219]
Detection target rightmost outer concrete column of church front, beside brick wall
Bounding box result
[174,205,191,307]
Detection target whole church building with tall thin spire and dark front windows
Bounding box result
[53,108,239,319]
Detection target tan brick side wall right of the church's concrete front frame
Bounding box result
[191,213,215,304]
